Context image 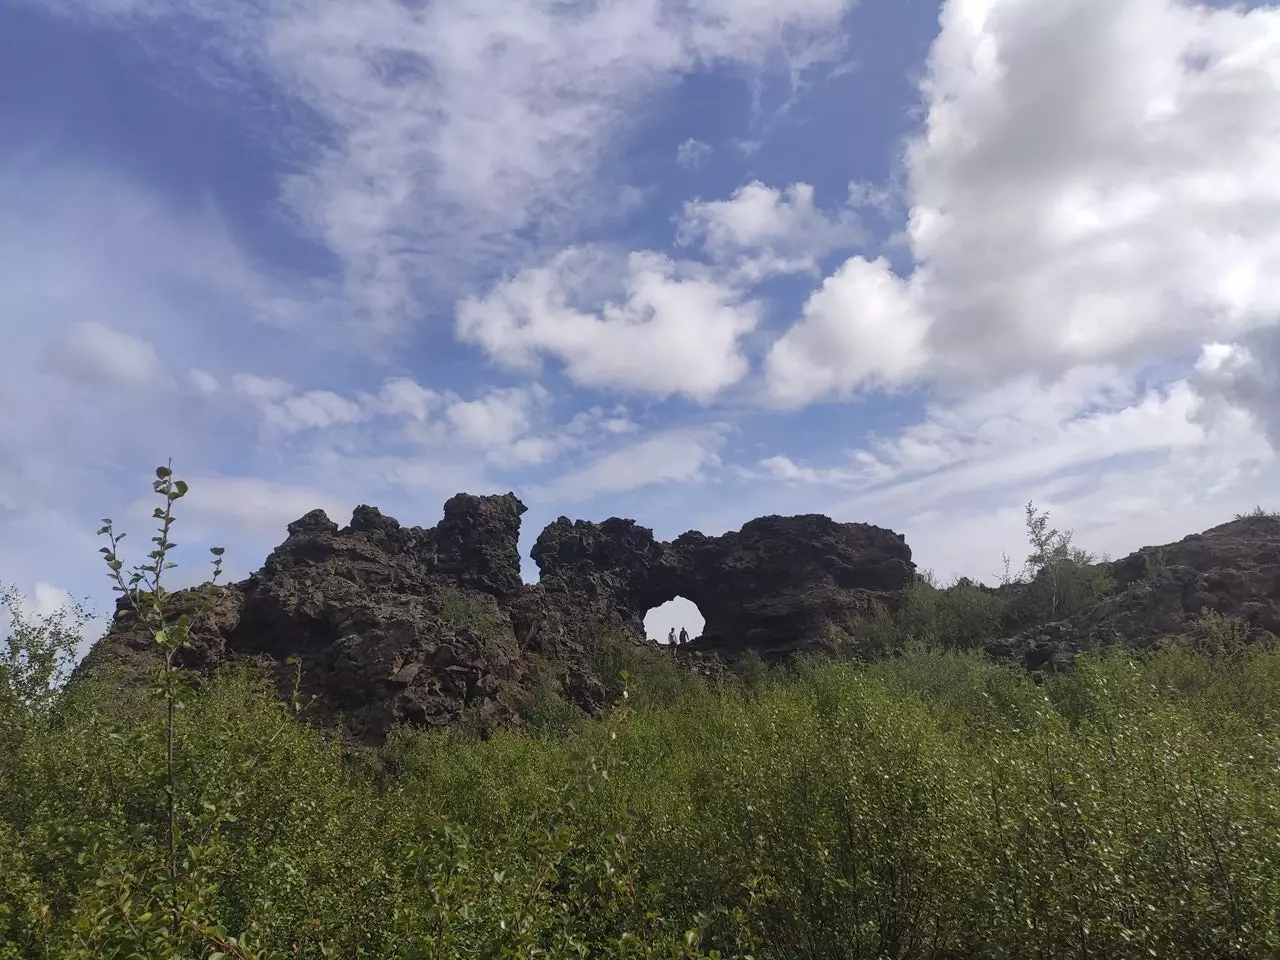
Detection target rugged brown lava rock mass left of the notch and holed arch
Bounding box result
[81,494,525,741]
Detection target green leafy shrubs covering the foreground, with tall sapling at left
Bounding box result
[0,472,1280,960]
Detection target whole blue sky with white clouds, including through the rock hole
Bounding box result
[0,0,1280,647]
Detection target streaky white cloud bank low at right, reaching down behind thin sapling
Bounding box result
[744,367,1280,582]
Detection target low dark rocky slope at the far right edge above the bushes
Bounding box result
[991,517,1280,669]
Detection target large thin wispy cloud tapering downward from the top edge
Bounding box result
[58,0,854,329]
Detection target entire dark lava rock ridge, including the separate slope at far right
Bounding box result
[78,493,1280,742]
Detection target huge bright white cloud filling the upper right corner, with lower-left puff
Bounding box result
[767,0,1280,403]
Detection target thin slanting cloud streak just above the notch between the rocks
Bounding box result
[530,425,724,500]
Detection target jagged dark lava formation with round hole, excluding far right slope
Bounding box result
[78,494,914,742]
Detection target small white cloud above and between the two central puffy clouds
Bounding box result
[677,180,864,283]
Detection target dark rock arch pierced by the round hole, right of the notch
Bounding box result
[514,515,915,657]
